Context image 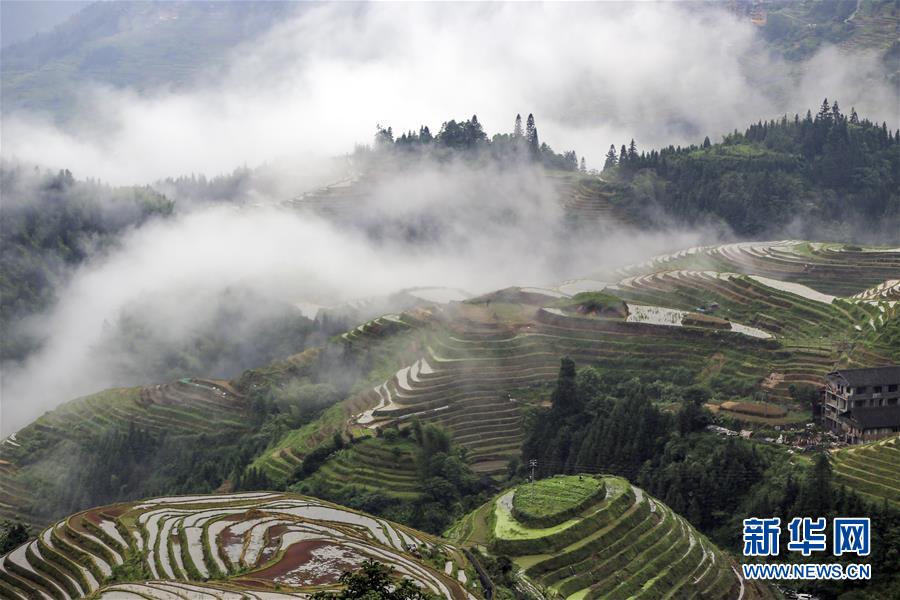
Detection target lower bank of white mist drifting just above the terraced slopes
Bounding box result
[2,157,713,433]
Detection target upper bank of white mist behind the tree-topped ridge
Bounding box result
[2,2,897,184]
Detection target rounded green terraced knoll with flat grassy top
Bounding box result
[447,475,770,600]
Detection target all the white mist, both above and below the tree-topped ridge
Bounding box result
[0,3,896,435]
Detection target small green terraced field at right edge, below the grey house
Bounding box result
[831,436,900,507]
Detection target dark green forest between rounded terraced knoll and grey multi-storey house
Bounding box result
[522,358,900,598]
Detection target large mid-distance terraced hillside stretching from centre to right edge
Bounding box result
[334,241,900,472]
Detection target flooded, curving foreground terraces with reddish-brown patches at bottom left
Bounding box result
[0,492,474,600]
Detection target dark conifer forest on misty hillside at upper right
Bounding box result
[603,99,900,241]
